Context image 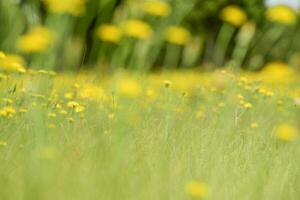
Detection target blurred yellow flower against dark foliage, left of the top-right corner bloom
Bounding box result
[220,5,247,27]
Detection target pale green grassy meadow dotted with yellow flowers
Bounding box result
[0,68,300,200]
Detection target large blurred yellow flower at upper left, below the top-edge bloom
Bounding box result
[17,26,54,53]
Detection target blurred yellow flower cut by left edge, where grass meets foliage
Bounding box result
[0,54,26,73]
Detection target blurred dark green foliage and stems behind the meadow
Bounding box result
[0,0,300,71]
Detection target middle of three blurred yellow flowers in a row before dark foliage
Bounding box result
[123,20,153,40]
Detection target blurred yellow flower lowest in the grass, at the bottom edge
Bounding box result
[186,181,208,198]
